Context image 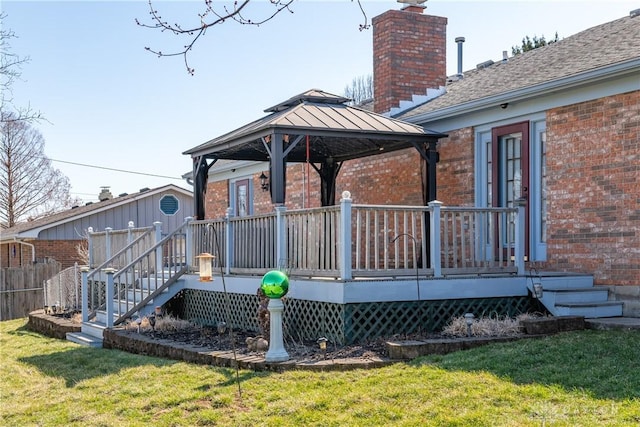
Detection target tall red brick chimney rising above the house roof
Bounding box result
[372,0,447,113]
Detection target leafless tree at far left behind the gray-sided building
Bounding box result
[0,113,73,227]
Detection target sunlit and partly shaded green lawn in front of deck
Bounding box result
[0,319,640,426]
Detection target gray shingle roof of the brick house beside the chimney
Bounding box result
[398,16,640,121]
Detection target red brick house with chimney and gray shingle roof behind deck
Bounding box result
[188,6,640,294]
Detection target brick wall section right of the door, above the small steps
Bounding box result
[546,91,640,285]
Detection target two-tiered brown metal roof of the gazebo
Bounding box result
[184,89,445,163]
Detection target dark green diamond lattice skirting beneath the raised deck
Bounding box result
[170,289,538,344]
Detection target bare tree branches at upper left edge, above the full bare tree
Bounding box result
[0,13,42,123]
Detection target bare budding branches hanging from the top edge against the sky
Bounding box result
[136,0,370,75]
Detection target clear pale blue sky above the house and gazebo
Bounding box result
[0,0,640,202]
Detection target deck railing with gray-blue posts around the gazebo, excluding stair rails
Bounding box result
[185,198,524,280]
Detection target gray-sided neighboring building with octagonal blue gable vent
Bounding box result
[0,184,193,268]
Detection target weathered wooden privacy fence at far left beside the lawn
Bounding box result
[0,261,61,320]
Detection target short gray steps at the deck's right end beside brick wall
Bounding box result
[527,274,623,319]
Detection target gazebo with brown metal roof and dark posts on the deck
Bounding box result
[183,89,446,219]
